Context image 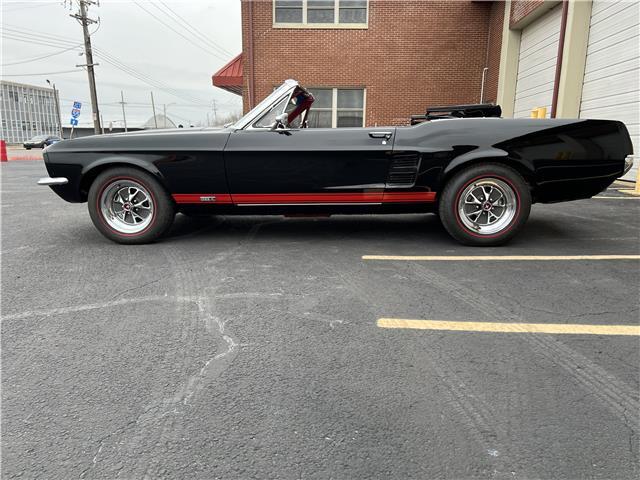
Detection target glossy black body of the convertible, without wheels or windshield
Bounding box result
[45,118,632,213]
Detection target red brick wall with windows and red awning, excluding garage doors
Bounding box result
[213,0,504,127]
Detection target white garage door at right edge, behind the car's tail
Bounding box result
[580,0,640,180]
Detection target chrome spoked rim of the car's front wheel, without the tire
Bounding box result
[98,179,154,234]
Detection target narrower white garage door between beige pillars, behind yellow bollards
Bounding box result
[513,5,562,118]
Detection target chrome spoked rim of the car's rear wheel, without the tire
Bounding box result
[458,178,518,235]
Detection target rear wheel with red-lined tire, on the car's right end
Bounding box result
[439,163,531,246]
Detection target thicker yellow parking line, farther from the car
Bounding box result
[377,318,640,336]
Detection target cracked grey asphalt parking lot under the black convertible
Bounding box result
[0,161,640,479]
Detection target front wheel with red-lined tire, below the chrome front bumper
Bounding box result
[88,167,175,244]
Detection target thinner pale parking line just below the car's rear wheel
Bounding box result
[362,255,640,262]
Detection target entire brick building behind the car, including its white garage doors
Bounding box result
[213,0,640,179]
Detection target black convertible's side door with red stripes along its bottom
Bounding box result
[224,128,395,205]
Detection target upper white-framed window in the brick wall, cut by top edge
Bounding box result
[273,0,368,28]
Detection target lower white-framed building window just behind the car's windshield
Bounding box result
[307,88,365,128]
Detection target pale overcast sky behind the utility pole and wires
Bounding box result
[0,0,242,127]
